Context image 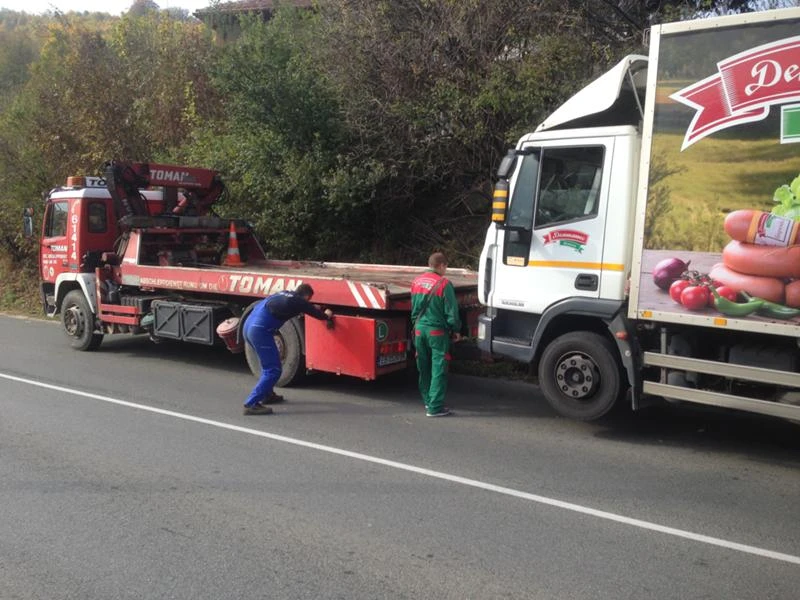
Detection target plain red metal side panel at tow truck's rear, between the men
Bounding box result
[305,315,377,380]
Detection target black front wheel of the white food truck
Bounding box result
[539,331,622,421]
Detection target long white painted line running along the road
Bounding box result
[0,373,800,565]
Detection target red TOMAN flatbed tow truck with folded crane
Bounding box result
[40,161,480,386]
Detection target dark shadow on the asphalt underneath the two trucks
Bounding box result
[100,336,800,460]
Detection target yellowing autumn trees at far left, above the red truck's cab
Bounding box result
[0,12,219,268]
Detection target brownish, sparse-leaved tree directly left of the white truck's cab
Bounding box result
[314,0,607,262]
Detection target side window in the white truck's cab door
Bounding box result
[534,146,604,229]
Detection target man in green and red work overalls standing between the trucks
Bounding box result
[411,252,461,417]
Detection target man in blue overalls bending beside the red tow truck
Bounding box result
[244,283,333,415]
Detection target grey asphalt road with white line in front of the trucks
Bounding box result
[0,317,800,600]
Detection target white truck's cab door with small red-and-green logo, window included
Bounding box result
[492,138,622,314]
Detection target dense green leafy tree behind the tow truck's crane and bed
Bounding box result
[192,7,381,260]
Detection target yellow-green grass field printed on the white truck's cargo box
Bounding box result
[653,133,800,252]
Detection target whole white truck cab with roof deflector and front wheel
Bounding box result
[478,56,647,418]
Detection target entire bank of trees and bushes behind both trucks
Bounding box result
[0,0,780,300]
